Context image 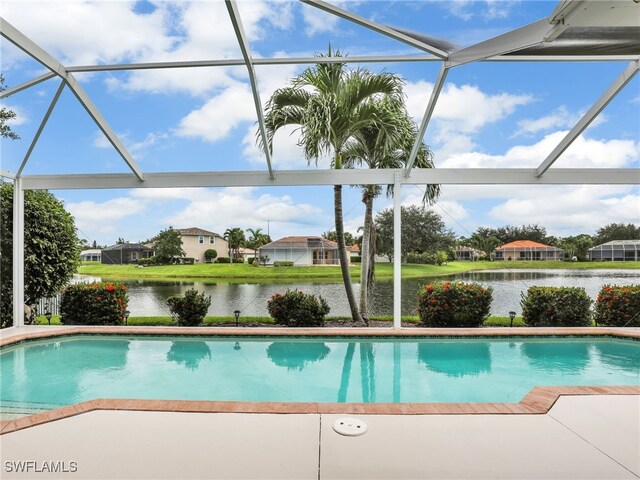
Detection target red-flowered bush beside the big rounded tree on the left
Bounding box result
[60,282,129,325]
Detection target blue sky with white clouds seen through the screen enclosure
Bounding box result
[0,0,640,245]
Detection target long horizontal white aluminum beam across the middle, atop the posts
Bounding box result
[22,168,640,190]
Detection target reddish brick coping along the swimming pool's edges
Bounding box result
[0,326,640,435]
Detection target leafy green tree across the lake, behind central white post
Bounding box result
[375,205,455,262]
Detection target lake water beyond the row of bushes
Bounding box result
[77,269,640,316]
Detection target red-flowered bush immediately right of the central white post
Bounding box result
[418,282,493,327]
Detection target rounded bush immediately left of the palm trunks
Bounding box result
[267,290,329,327]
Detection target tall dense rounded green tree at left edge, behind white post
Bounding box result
[0,182,80,327]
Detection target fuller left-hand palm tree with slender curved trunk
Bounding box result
[258,47,402,321]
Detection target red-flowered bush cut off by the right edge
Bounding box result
[595,285,640,327]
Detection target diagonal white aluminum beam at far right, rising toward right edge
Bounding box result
[536,61,640,177]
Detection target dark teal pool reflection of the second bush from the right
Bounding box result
[520,341,590,373]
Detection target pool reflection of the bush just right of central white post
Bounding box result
[418,343,491,377]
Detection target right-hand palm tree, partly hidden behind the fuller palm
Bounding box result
[344,98,440,318]
